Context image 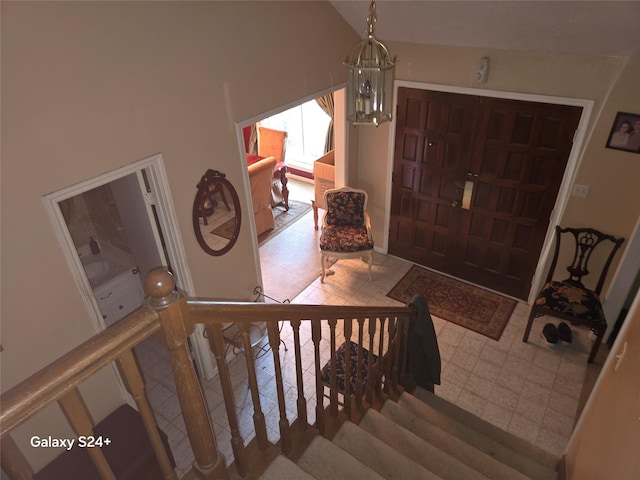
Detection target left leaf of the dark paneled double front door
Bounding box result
[389,89,478,272]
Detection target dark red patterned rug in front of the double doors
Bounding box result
[387,265,516,340]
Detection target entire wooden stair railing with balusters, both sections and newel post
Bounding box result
[0,268,416,480]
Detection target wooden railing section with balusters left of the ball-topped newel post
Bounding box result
[0,292,177,480]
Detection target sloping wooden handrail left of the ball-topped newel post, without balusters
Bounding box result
[0,307,160,436]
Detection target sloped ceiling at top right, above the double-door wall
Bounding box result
[331,0,640,57]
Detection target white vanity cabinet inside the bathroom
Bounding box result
[93,269,144,326]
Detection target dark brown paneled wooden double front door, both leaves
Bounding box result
[389,88,582,299]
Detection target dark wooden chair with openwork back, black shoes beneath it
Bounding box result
[522,226,624,363]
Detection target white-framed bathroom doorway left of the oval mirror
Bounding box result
[43,154,215,378]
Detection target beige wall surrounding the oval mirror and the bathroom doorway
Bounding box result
[1,2,357,466]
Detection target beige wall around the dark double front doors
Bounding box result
[358,42,640,291]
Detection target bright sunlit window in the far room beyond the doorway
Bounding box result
[260,100,331,172]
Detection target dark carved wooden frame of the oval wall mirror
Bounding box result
[192,169,242,257]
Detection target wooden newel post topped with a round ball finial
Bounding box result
[144,267,229,480]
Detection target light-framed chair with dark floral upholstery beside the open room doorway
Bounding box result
[320,187,373,282]
